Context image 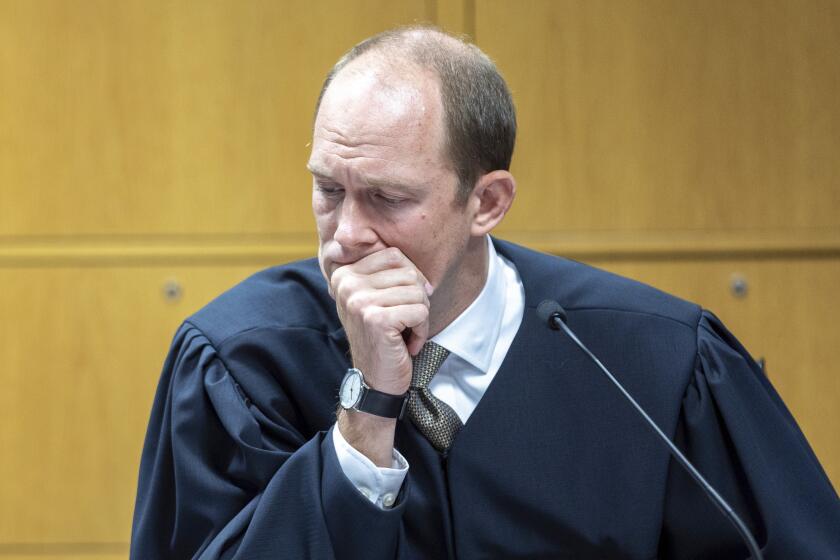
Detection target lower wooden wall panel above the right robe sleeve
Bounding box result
[592,257,840,487]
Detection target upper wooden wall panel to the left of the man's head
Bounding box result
[0,0,434,236]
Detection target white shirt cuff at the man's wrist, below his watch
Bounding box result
[332,424,408,509]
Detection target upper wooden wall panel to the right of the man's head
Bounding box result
[475,0,840,232]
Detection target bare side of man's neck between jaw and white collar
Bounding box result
[429,236,489,338]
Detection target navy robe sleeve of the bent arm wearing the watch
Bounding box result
[131,323,408,560]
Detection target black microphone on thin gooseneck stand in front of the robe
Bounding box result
[537,299,764,560]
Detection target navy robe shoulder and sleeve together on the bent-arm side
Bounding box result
[131,261,405,560]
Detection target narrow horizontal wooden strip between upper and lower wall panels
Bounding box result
[0,230,840,267]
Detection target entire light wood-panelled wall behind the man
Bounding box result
[0,0,840,559]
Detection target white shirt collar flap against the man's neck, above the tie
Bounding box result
[431,235,506,373]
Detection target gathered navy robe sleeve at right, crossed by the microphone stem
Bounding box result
[659,312,840,560]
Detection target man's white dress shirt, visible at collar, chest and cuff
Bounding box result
[333,236,525,508]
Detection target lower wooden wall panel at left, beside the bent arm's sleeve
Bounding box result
[0,259,270,544]
